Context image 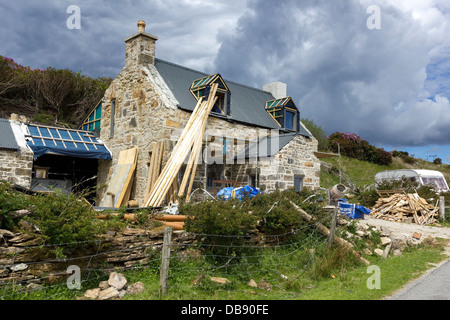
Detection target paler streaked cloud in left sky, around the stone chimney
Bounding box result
[0,0,245,77]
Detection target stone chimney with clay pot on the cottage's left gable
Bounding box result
[125,20,158,67]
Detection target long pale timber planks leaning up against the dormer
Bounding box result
[145,84,218,207]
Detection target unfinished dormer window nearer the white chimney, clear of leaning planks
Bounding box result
[266,97,300,131]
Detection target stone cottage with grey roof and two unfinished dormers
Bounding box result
[95,21,320,205]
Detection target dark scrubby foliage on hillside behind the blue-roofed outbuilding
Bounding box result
[0,56,112,126]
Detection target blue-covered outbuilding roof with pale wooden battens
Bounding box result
[25,124,112,160]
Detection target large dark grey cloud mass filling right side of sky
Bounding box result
[216,0,450,145]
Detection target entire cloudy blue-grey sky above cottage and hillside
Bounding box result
[0,0,450,164]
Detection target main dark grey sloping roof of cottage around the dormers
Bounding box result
[155,59,311,137]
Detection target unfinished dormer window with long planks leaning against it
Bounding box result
[190,73,231,116]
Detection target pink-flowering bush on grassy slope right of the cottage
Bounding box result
[328,132,392,165]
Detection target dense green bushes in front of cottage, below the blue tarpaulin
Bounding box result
[179,190,326,257]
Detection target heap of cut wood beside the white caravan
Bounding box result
[370,193,439,225]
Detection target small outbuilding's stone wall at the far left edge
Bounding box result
[0,149,33,188]
